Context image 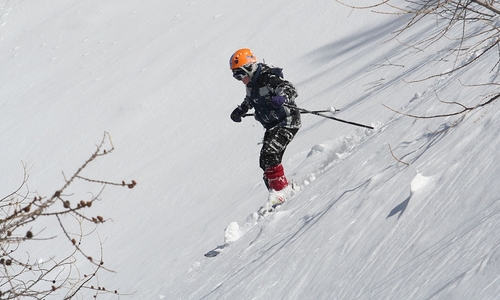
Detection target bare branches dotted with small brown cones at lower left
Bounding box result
[0,132,136,300]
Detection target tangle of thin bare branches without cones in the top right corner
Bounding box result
[342,0,500,83]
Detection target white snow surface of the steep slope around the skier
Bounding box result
[0,0,500,299]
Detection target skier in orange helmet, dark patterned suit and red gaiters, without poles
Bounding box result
[229,48,301,212]
